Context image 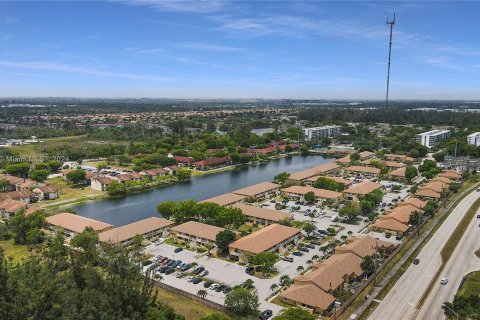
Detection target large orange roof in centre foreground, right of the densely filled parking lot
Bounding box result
[228,224,300,253]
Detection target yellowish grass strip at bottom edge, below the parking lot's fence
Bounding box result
[158,289,225,320]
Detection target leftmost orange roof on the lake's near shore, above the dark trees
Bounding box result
[45,212,113,233]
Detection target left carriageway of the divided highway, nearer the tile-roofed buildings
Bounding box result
[369,189,480,320]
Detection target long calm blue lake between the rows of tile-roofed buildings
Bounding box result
[73,156,333,226]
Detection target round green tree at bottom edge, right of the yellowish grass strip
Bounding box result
[225,287,260,317]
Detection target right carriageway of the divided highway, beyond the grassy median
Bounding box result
[416,199,480,319]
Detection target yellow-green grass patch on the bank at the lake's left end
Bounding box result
[39,177,106,206]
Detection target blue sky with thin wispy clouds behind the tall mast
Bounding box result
[0,0,480,100]
